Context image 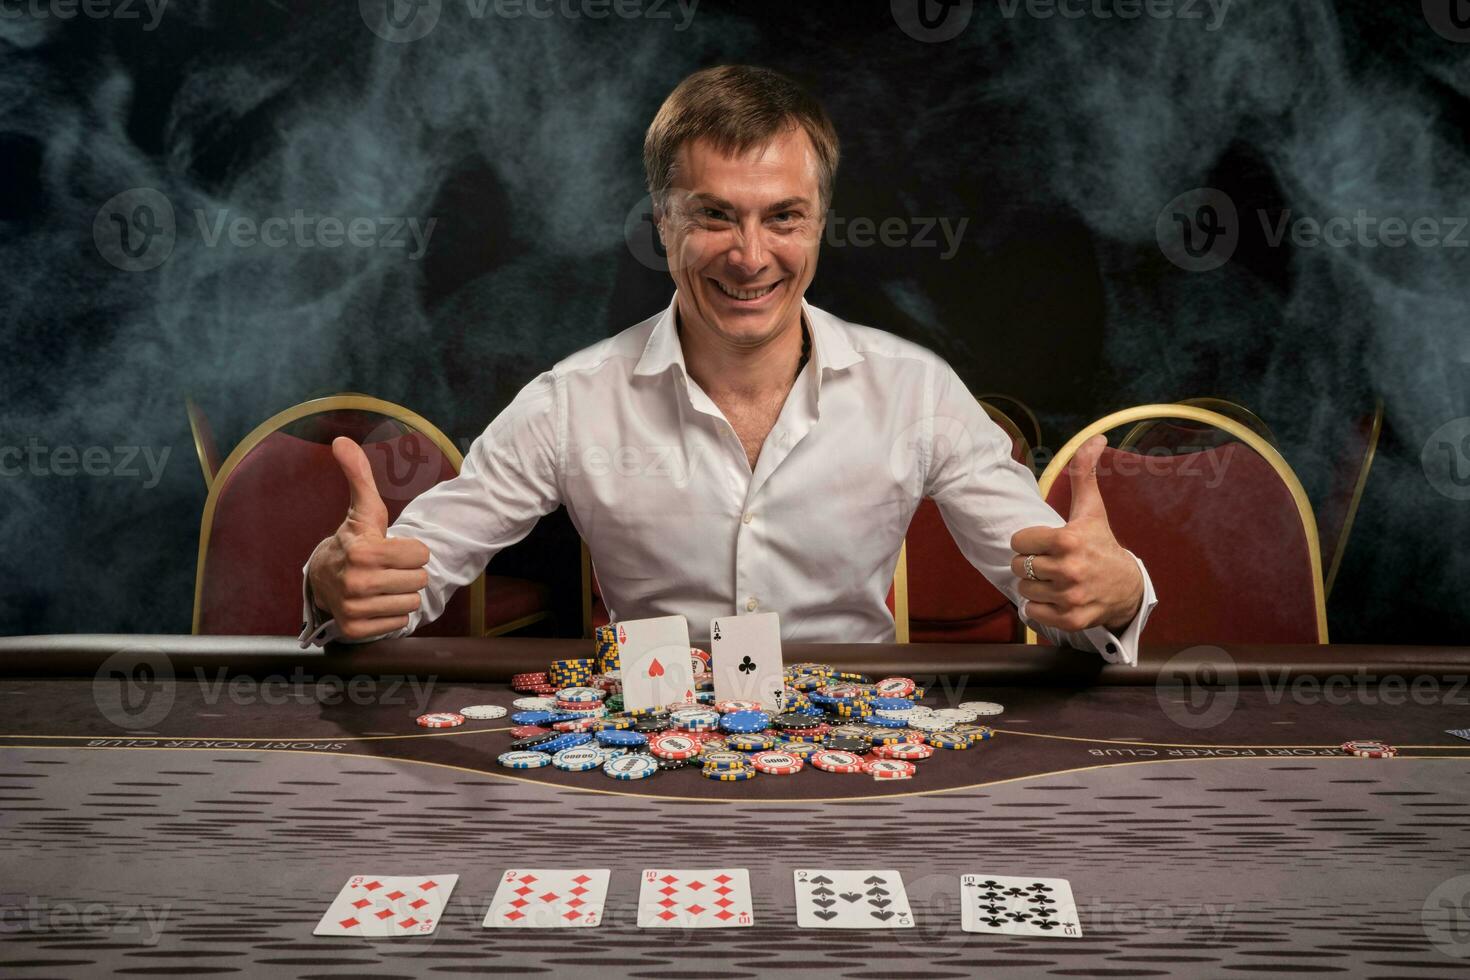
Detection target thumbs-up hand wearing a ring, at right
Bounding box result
[1011,435,1144,632]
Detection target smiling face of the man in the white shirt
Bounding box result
[659,126,823,350]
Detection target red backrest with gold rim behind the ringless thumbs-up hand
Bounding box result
[194,395,485,636]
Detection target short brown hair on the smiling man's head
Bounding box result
[644,65,838,215]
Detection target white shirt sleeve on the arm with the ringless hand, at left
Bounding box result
[300,372,563,646]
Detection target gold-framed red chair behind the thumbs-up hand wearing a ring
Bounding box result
[1026,404,1327,644]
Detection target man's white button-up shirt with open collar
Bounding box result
[301,287,1155,664]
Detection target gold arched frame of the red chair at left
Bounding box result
[193,394,490,636]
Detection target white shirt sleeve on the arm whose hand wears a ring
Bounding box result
[919,359,1157,666]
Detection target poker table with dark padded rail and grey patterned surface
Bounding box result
[0,636,1470,979]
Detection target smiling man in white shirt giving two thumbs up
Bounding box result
[301,66,1155,663]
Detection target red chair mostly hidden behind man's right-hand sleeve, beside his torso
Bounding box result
[906,398,1032,644]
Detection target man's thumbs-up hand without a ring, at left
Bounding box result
[307,436,429,639]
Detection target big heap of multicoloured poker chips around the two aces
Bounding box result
[498,648,1004,782]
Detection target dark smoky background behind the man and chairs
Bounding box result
[0,0,1470,644]
